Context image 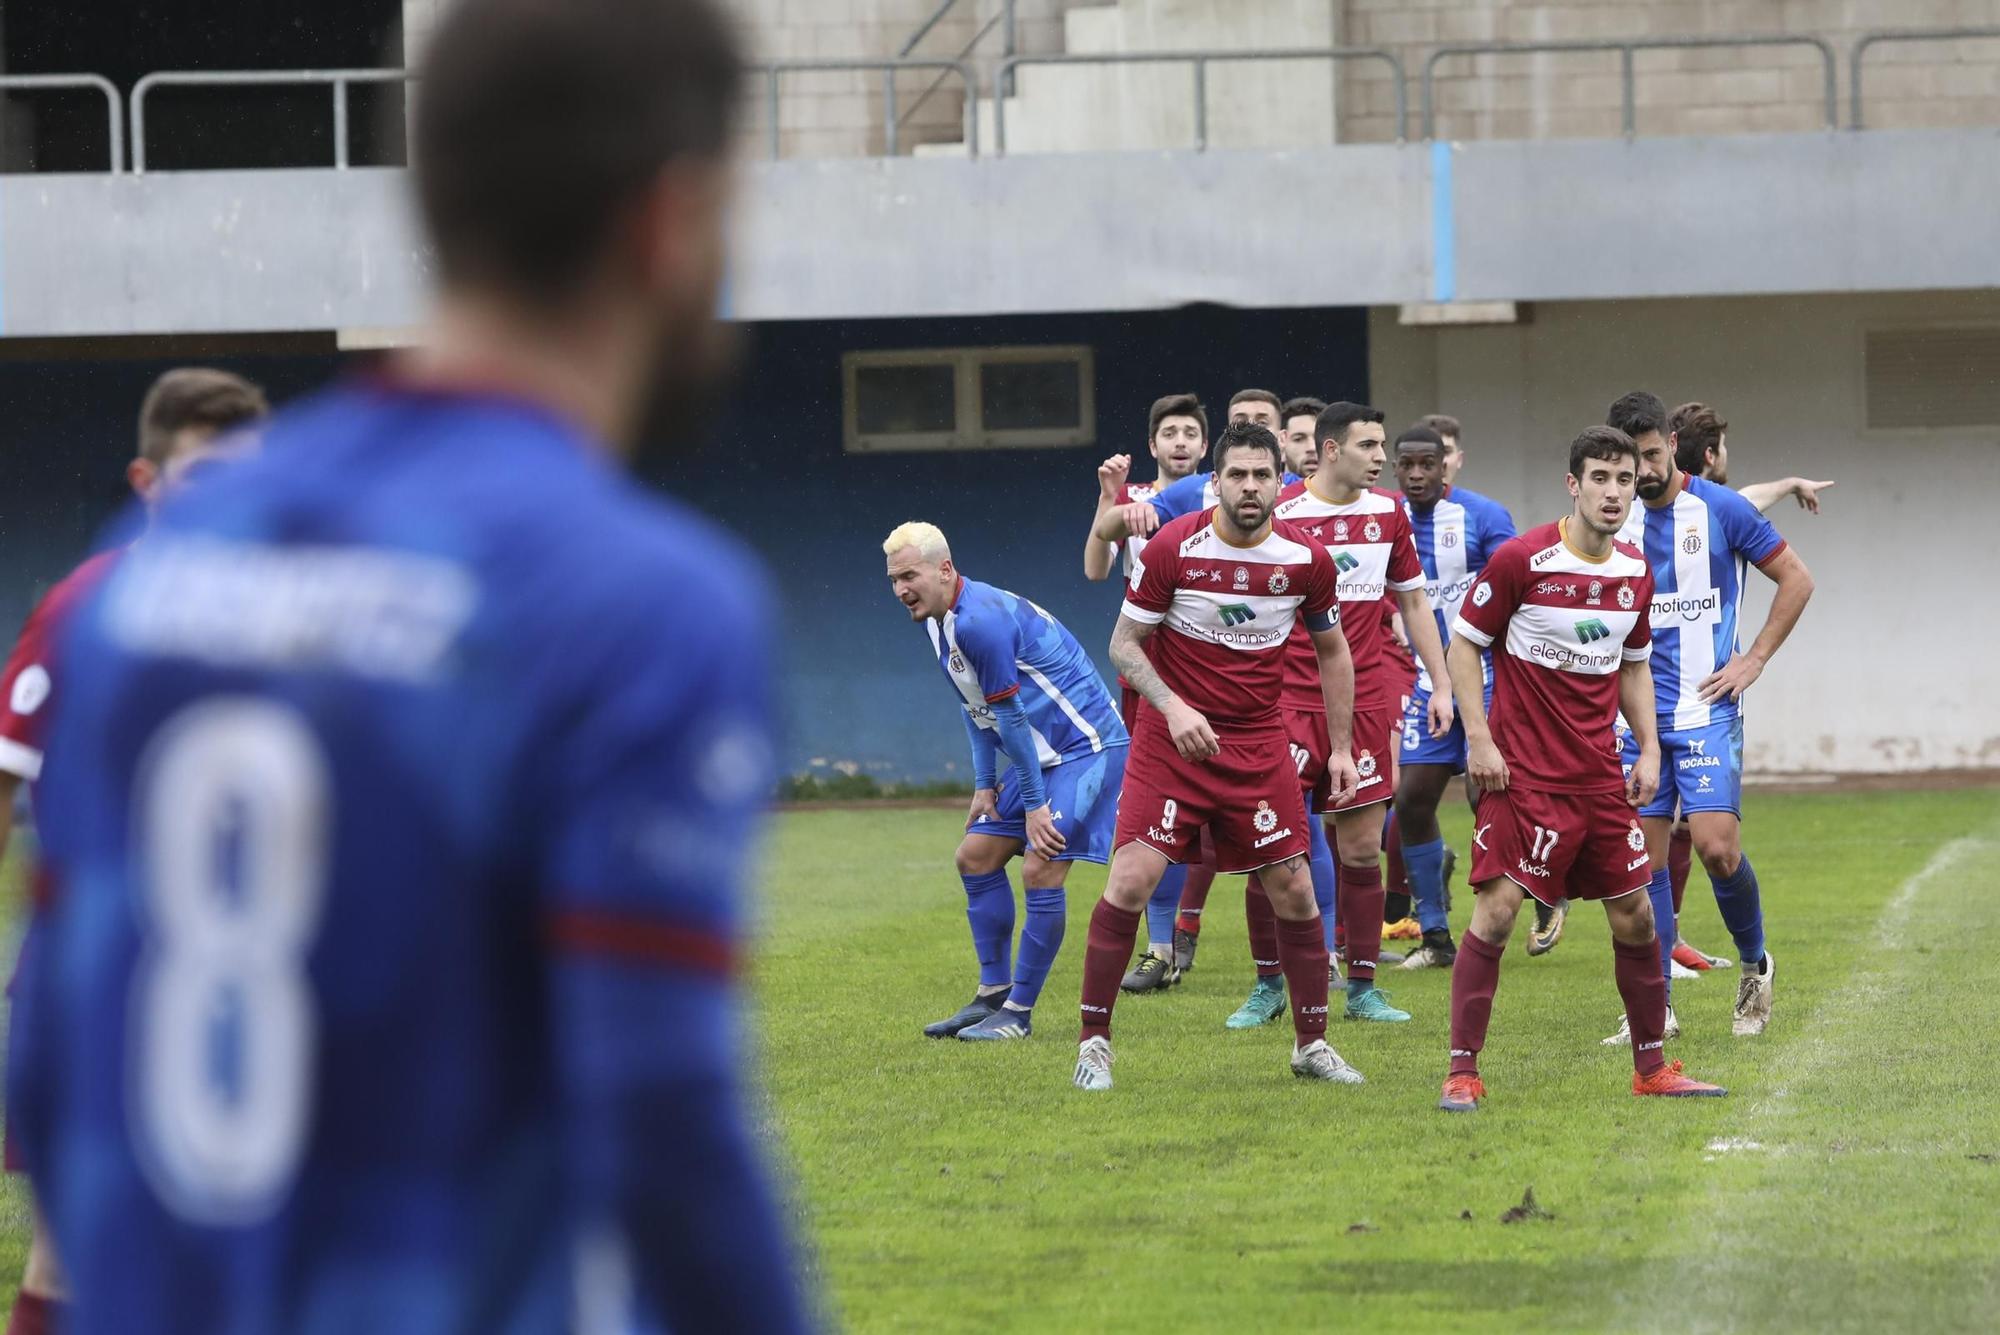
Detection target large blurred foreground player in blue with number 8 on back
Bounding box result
[8,0,806,1335]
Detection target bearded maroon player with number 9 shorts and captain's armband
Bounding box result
[1074,422,1360,1089]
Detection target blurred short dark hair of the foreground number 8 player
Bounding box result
[412,0,742,304]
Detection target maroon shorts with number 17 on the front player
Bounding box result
[1472,787,1652,903]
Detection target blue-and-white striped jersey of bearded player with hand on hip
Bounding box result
[1618,474,1784,729]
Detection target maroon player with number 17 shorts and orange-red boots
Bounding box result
[1438,426,1726,1113]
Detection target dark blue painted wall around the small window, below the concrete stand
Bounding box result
[0,308,1368,779]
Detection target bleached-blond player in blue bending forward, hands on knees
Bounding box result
[882,522,1126,1041]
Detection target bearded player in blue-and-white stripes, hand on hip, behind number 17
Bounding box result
[1606,390,1812,1043]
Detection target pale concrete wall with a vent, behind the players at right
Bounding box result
[1370,292,2000,771]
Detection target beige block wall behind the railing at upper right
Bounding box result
[1338,0,2000,142]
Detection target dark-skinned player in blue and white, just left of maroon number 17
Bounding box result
[1396,426,1514,969]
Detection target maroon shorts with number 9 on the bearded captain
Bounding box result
[1112,709,1310,875]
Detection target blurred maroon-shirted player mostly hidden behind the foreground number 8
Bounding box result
[0,366,270,1335]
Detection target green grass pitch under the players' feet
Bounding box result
[756,789,2000,1331]
